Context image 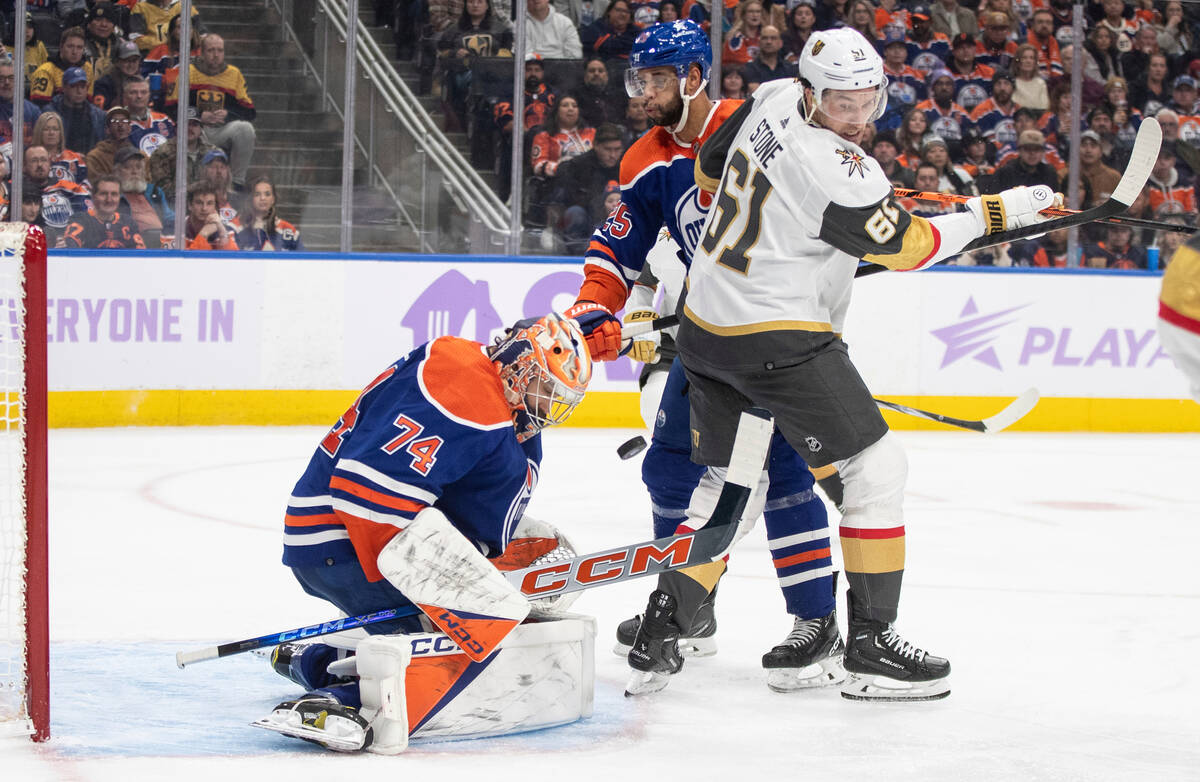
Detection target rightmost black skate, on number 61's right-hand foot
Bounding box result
[841,592,950,700]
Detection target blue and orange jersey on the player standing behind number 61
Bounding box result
[580,101,742,312]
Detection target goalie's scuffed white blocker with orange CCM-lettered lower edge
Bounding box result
[376,507,529,662]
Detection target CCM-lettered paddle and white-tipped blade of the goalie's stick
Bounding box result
[505,408,775,597]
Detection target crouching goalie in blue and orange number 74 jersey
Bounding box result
[256,313,592,751]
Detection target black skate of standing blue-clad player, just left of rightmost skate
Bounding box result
[762,609,846,692]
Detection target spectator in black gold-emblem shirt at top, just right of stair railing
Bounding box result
[434,0,512,131]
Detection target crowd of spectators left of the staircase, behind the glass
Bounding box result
[0,0,304,249]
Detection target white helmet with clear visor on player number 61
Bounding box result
[799,28,888,125]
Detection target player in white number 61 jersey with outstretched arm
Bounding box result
[678,29,1060,700]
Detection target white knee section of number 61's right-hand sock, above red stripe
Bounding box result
[835,432,908,529]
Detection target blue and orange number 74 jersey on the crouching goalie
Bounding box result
[283,337,541,582]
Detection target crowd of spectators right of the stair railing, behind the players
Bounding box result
[376,0,1200,269]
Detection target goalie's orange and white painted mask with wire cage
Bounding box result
[491,312,592,443]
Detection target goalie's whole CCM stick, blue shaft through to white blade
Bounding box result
[175,408,775,668]
